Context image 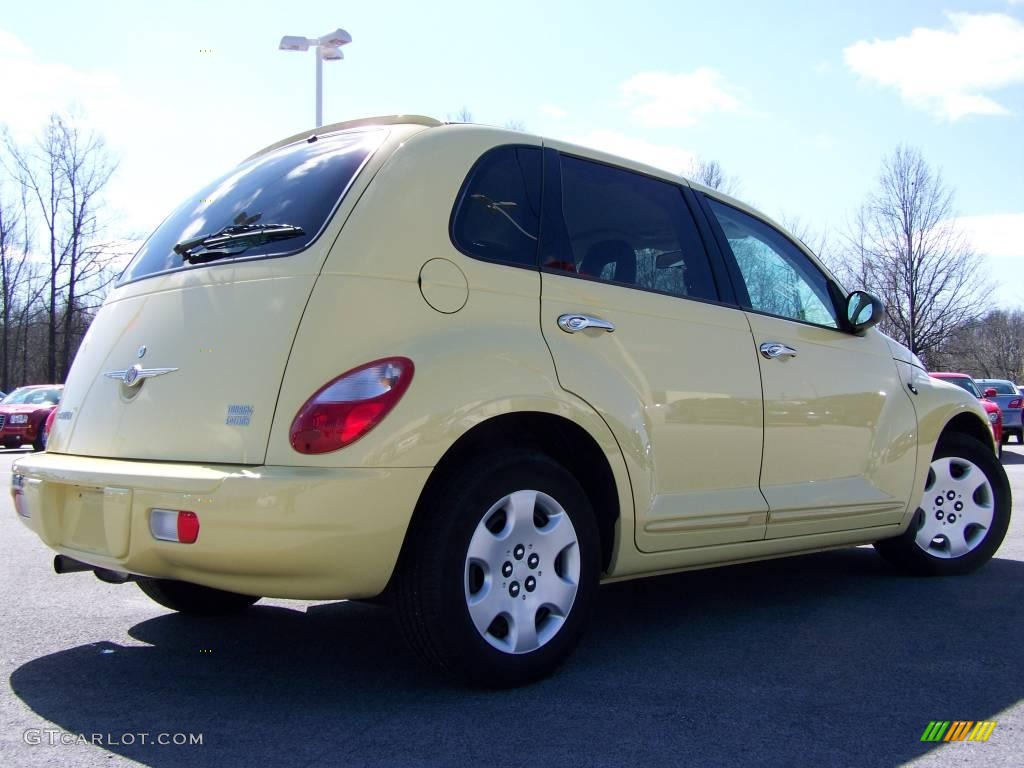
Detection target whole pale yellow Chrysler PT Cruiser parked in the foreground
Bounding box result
[12,116,1011,686]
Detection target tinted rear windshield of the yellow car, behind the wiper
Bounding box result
[119,129,385,284]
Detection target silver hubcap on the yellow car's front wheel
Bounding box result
[914,457,994,559]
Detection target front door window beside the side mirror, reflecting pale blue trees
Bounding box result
[707,198,839,328]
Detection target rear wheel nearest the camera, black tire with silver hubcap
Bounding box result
[394,451,600,688]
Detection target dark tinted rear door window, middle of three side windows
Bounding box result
[547,156,718,301]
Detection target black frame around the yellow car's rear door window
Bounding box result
[538,146,738,309]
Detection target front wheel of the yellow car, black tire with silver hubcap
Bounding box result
[874,434,1011,575]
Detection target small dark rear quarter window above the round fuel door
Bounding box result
[452,146,541,267]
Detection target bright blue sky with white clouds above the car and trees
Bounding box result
[0,0,1024,306]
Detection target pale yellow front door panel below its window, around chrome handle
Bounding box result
[749,312,918,538]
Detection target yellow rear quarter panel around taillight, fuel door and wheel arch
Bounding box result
[267,129,633,546]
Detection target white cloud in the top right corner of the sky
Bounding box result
[843,13,1024,120]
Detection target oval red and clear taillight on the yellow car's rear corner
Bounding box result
[289,357,413,454]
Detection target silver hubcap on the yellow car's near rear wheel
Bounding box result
[465,490,580,653]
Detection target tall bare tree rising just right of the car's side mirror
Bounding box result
[847,146,987,358]
